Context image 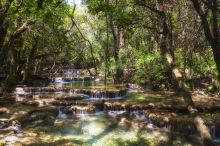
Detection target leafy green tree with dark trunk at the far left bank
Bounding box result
[0,0,72,91]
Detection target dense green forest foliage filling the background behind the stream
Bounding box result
[0,0,220,91]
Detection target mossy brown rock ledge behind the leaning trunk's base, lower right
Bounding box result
[145,111,220,139]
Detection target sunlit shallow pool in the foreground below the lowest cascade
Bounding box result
[1,112,199,146]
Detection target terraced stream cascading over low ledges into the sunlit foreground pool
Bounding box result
[0,70,217,146]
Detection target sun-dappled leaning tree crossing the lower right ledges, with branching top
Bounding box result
[137,1,214,146]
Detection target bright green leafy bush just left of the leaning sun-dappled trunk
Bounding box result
[133,52,169,89]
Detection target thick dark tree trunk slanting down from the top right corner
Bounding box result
[191,0,220,81]
